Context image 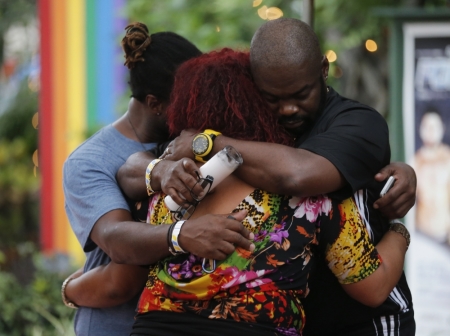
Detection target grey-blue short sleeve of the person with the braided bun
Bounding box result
[63,159,129,252]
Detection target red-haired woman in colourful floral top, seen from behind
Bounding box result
[67,49,408,335]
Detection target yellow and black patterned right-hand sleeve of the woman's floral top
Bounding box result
[320,198,382,284]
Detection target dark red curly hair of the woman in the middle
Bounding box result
[167,48,293,145]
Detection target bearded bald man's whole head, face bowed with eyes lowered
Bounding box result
[250,18,329,137]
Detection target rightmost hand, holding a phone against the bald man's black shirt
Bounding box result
[373,162,417,219]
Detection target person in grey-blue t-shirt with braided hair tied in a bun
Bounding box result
[63,23,201,336]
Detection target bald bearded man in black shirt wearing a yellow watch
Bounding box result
[115,19,415,335]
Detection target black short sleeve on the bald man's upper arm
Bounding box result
[300,108,390,197]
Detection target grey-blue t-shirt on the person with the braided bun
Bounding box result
[63,125,155,336]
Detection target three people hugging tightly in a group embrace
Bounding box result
[62,18,415,336]
